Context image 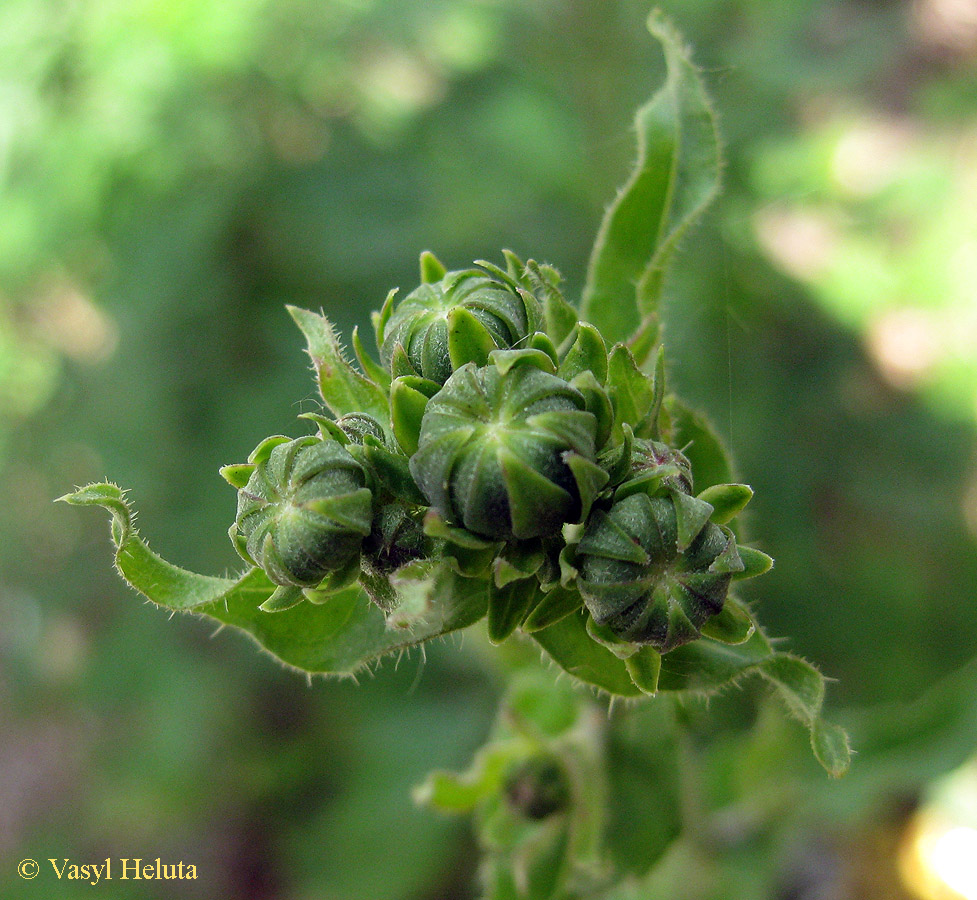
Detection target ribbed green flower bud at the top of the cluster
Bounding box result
[380,269,542,384]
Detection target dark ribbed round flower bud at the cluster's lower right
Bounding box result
[575,490,743,653]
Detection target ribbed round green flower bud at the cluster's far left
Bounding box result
[230,436,373,587]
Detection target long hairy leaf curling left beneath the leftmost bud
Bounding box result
[60,484,487,674]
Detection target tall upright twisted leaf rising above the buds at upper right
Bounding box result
[581,14,720,341]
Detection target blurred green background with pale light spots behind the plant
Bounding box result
[0,0,977,900]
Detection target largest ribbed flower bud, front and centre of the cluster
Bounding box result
[410,350,607,540]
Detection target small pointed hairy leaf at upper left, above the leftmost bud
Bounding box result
[286,306,390,423]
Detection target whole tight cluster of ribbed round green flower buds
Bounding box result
[222,253,770,657]
